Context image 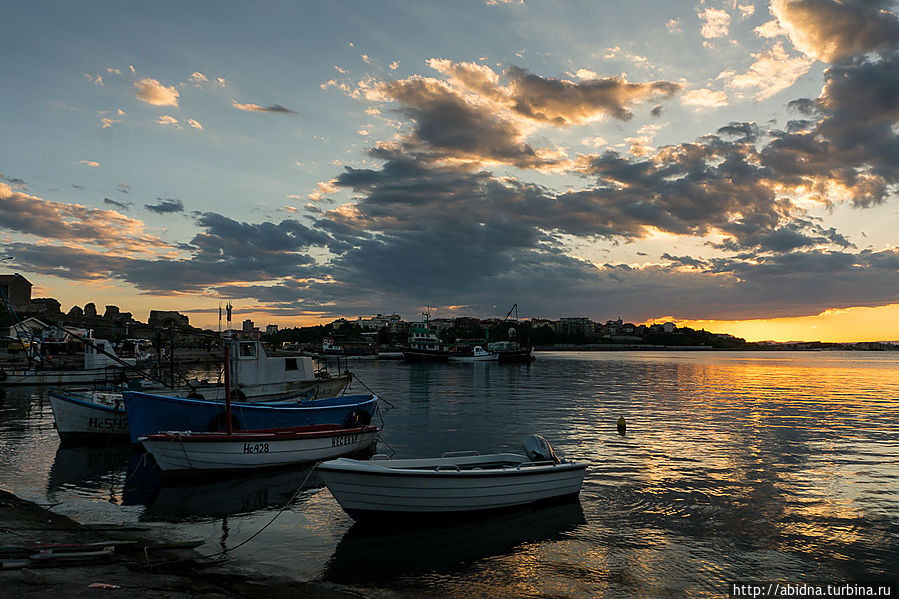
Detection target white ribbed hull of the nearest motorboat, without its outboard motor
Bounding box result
[317,459,586,521]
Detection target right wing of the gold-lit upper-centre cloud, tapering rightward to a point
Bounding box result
[505,66,683,125]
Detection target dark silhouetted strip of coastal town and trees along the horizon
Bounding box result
[0,273,899,358]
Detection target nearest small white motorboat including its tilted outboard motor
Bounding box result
[317,435,586,521]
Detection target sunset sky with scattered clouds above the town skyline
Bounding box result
[0,0,899,341]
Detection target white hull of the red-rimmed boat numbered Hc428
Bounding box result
[141,426,378,476]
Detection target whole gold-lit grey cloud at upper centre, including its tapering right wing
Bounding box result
[366,59,681,168]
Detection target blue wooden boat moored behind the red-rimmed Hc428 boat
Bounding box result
[123,391,378,443]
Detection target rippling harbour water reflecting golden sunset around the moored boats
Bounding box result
[0,352,899,597]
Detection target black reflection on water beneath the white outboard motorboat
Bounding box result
[322,501,586,586]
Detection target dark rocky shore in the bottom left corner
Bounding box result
[0,490,369,599]
